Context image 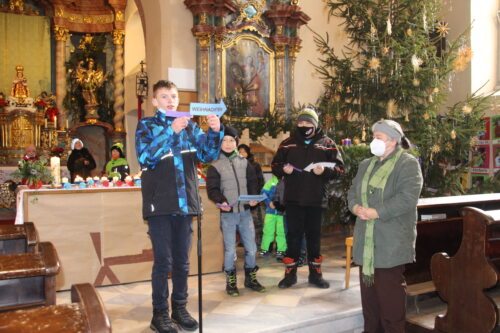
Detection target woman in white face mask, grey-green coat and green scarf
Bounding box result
[348,120,423,333]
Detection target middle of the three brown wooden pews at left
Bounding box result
[0,242,60,311]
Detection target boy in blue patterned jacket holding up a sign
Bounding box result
[135,80,224,333]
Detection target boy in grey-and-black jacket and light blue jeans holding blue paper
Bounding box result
[207,126,265,296]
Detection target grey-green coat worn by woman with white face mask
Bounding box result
[348,148,423,268]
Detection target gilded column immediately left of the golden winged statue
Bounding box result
[54,25,69,129]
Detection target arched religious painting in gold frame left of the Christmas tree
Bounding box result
[222,34,274,118]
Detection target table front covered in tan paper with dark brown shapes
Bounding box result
[16,187,223,290]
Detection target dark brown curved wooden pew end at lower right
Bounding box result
[407,207,500,333]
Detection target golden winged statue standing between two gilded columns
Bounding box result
[75,58,105,105]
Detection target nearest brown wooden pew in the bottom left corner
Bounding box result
[0,283,111,333]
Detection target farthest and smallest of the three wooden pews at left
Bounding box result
[0,222,38,255]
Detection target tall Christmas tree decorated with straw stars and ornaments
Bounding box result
[315,0,489,196]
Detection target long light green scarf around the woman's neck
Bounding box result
[361,149,403,286]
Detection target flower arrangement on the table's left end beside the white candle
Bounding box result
[11,157,53,188]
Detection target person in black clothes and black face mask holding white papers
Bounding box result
[271,108,343,288]
